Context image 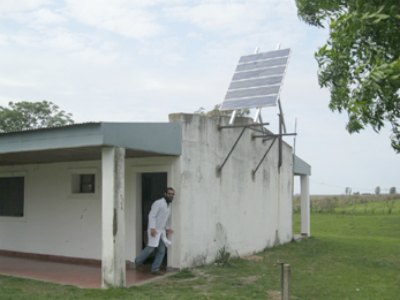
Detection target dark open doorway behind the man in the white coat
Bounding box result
[142,172,167,248]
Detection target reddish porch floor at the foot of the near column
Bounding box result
[0,255,170,288]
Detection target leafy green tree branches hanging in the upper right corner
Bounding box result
[296,0,400,153]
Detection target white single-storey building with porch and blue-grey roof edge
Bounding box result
[0,114,310,287]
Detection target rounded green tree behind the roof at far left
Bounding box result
[0,101,74,132]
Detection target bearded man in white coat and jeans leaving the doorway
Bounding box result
[135,187,175,275]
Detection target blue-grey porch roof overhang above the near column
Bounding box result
[0,122,182,165]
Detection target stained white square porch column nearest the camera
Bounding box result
[101,147,126,288]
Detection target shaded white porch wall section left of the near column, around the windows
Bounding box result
[0,162,101,259]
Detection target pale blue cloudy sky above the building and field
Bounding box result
[0,0,400,194]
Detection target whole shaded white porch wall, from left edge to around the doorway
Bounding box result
[0,157,176,260]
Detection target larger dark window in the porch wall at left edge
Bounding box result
[0,177,24,217]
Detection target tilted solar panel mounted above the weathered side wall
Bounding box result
[221,49,290,110]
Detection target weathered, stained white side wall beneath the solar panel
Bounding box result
[170,114,293,267]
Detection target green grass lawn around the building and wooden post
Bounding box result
[0,200,400,300]
